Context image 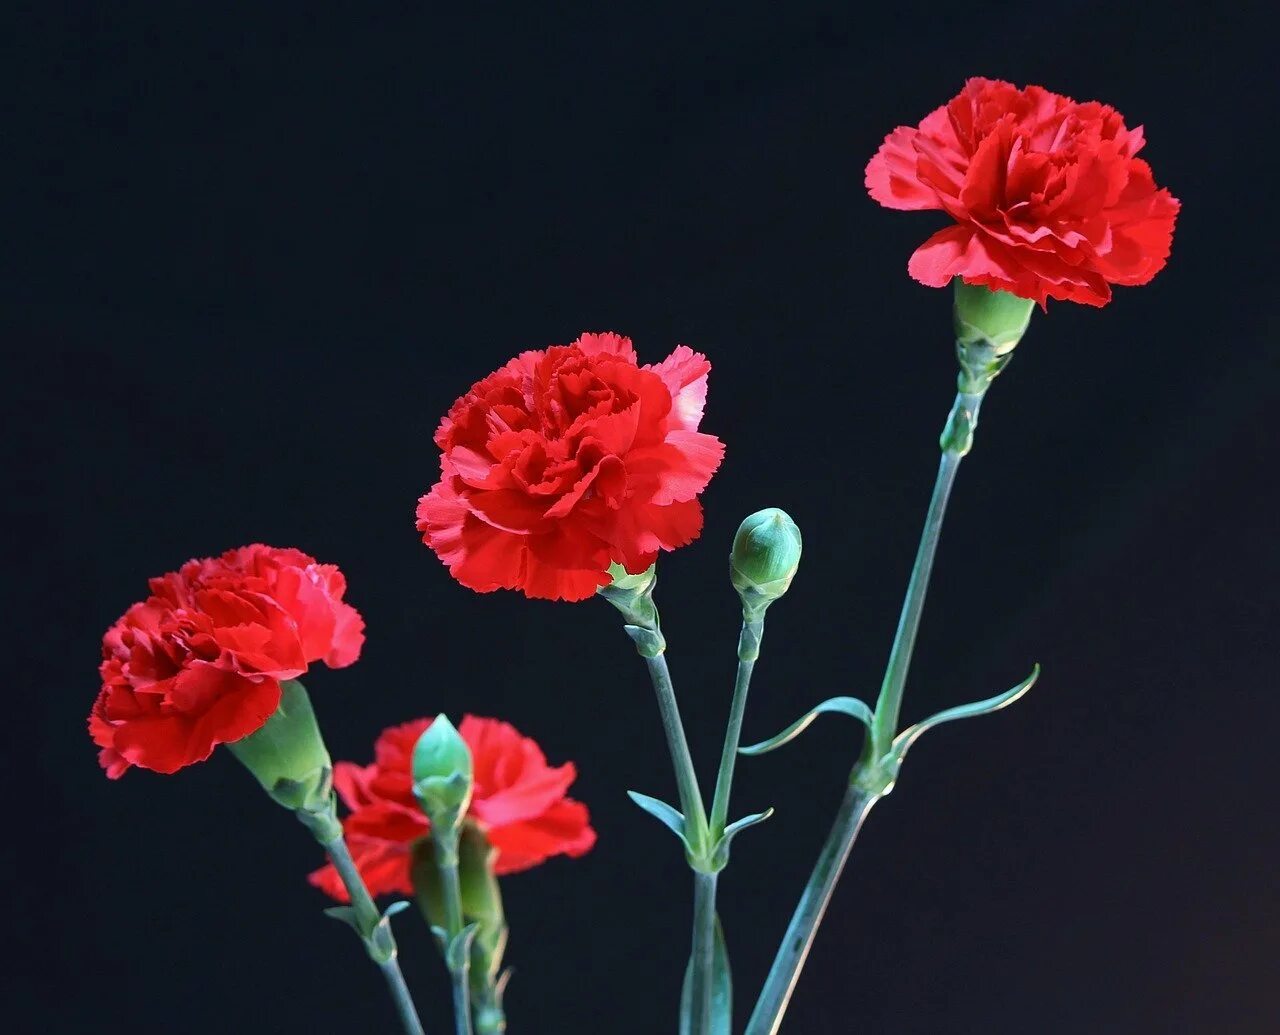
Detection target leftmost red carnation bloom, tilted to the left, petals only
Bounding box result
[88,544,365,779]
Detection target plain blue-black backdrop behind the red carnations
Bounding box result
[12,3,1280,1035]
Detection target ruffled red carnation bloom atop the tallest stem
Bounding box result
[867,79,1179,306]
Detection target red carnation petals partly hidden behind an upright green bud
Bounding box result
[308,715,595,902]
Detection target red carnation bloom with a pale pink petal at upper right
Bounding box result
[417,334,724,600]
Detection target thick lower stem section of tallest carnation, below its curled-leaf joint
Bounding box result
[746,784,879,1035]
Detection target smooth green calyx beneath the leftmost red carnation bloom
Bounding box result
[227,679,333,815]
